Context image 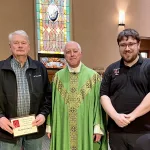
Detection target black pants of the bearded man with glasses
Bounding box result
[109,133,150,150]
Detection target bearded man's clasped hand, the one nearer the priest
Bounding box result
[114,113,130,128]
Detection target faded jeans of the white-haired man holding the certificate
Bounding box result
[0,137,43,150]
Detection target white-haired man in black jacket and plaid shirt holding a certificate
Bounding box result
[0,30,51,150]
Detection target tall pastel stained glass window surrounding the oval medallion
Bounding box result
[36,0,70,54]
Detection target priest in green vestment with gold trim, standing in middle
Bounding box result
[47,41,107,150]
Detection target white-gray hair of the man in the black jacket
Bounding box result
[8,30,30,43]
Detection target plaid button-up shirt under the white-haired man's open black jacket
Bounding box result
[11,58,30,116]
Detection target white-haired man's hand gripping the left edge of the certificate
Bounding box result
[0,117,14,134]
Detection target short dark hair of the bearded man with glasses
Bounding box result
[117,29,141,45]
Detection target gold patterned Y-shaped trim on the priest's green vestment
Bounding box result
[54,73,100,150]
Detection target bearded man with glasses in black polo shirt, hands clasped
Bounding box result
[100,29,150,150]
